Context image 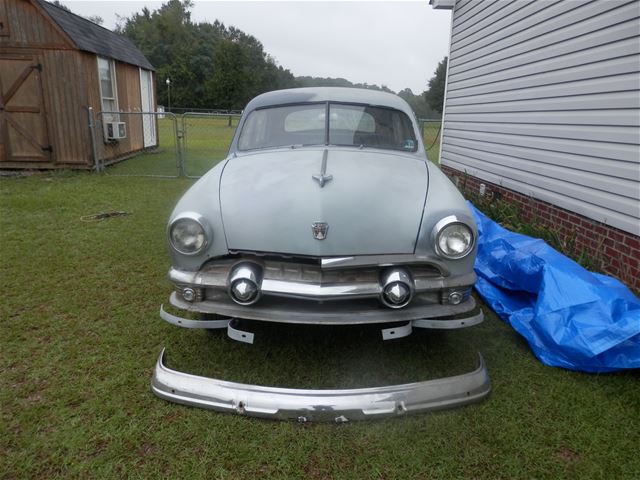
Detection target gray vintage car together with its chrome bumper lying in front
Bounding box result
[153,88,489,419]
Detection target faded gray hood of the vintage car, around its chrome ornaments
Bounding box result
[220,147,428,256]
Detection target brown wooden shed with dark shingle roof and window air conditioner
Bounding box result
[0,0,157,169]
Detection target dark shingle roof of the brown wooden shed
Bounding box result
[36,0,154,70]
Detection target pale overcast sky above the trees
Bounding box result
[62,0,451,94]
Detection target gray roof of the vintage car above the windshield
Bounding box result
[245,87,413,118]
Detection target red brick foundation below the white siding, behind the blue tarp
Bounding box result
[441,165,640,293]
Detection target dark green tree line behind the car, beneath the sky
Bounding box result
[116,0,446,118]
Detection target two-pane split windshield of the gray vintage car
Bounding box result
[238,103,418,152]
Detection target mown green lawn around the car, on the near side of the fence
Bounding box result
[0,173,640,479]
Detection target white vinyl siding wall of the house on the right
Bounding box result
[440,0,640,235]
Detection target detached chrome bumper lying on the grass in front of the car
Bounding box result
[151,350,491,423]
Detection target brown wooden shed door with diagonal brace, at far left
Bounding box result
[0,55,51,162]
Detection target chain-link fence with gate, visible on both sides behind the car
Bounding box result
[89,109,441,178]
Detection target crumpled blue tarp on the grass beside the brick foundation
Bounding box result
[470,204,640,372]
